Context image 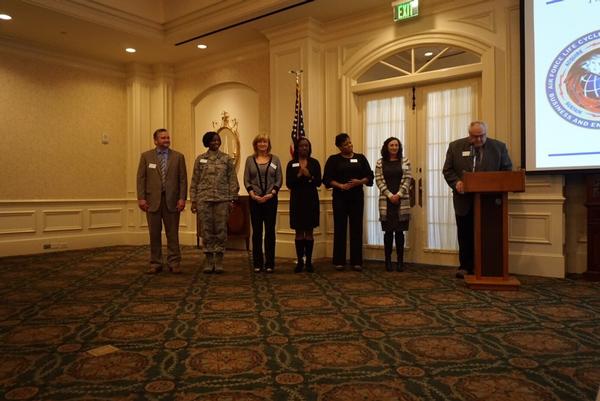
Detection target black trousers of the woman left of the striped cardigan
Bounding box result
[333,193,365,266]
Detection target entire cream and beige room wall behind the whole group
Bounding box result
[0,0,586,277]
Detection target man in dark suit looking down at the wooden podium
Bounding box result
[442,121,512,278]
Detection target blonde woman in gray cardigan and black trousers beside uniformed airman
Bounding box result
[244,134,282,273]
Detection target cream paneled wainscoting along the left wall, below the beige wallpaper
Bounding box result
[0,198,196,256]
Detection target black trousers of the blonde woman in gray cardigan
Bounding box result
[250,197,277,269]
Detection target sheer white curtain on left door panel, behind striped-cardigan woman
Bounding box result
[365,96,406,245]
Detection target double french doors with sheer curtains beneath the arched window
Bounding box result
[360,78,480,265]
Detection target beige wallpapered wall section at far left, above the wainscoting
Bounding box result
[0,51,127,200]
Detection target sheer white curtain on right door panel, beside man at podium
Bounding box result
[426,86,475,250]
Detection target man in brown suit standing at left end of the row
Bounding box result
[137,128,187,274]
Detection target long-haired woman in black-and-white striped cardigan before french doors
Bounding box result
[375,137,412,272]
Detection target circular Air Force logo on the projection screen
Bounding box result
[546,30,600,129]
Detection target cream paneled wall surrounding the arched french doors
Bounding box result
[267,0,576,277]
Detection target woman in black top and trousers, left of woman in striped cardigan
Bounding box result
[323,133,373,271]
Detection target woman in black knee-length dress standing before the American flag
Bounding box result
[285,138,321,273]
